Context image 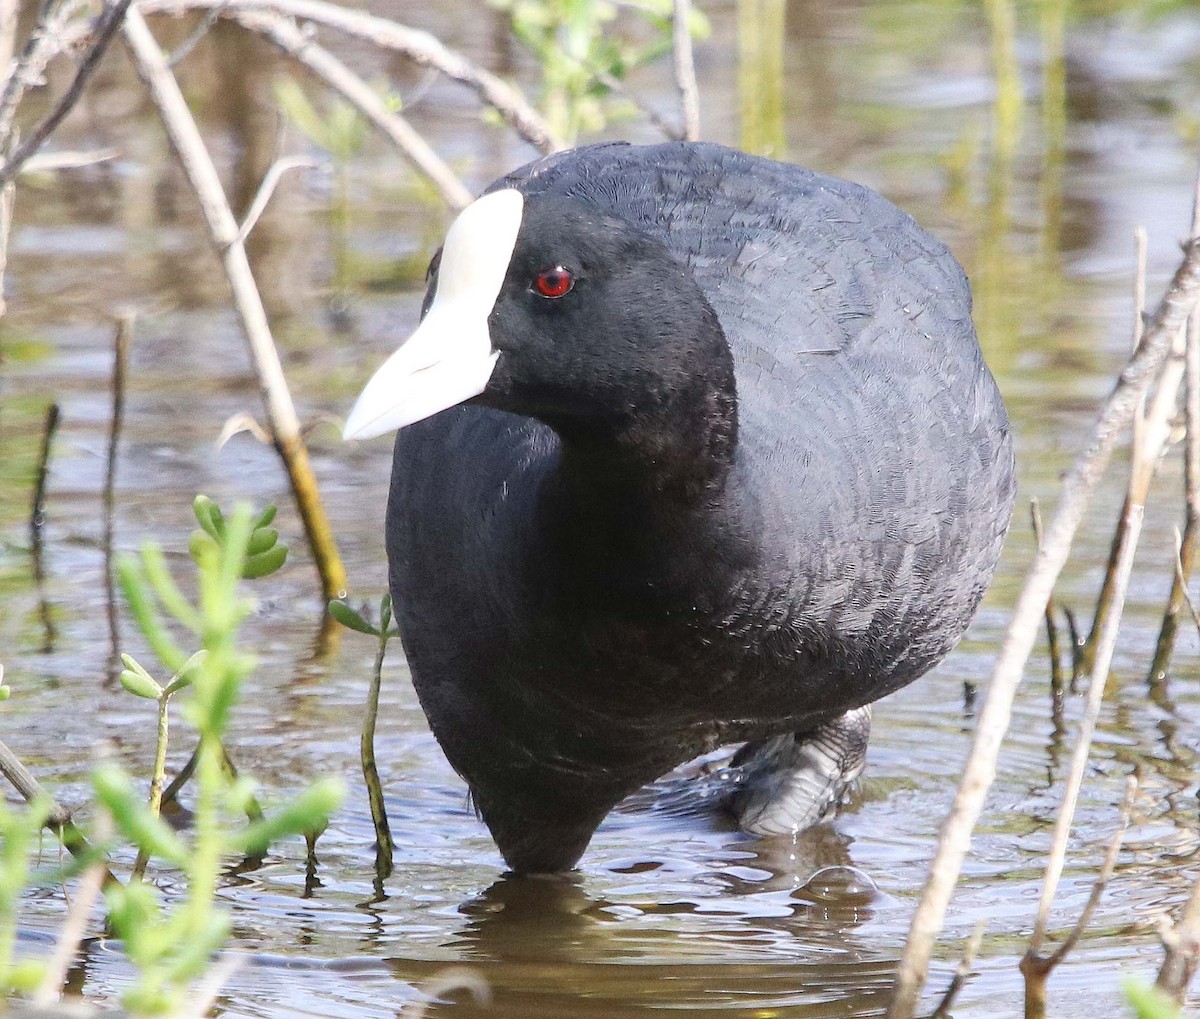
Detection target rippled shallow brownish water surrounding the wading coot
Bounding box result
[0,0,1200,1019]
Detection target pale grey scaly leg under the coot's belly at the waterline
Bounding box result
[730,705,871,835]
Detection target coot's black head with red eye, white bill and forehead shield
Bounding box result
[347,190,737,484]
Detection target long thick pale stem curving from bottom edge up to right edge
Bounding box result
[888,230,1200,1019]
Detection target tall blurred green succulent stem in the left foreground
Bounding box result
[105,496,342,1015]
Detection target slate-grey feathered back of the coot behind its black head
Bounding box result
[477,143,1014,696]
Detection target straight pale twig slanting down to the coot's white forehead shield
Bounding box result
[226,11,474,209]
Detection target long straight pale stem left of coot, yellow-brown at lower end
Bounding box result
[125,1,346,599]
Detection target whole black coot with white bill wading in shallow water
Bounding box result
[346,143,1013,873]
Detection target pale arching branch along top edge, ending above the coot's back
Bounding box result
[138,0,563,152]
